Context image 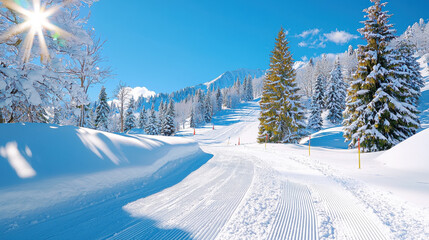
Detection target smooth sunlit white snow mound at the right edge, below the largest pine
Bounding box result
[377,129,429,173]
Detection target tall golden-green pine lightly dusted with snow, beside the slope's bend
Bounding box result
[258,28,304,143]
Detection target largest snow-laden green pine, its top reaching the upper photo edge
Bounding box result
[343,0,420,152]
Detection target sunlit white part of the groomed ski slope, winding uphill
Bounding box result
[111,101,429,239]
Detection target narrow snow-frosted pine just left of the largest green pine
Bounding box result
[326,58,347,124]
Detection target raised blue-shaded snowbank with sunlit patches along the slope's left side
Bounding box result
[0,123,200,187]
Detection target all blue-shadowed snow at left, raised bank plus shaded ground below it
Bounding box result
[0,124,211,239]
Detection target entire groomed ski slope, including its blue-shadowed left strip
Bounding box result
[0,101,429,240]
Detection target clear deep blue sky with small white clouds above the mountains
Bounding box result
[89,0,429,99]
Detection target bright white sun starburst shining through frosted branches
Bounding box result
[0,0,71,62]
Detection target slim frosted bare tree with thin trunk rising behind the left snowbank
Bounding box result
[67,34,112,127]
